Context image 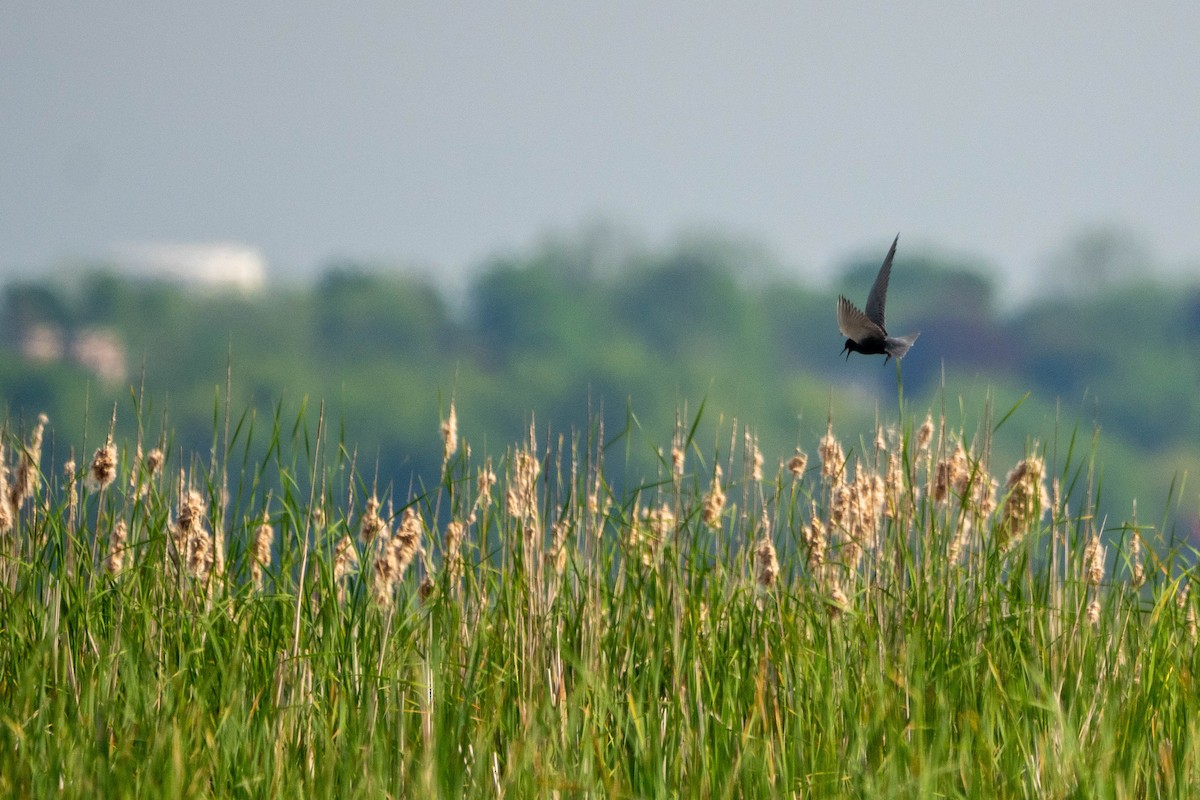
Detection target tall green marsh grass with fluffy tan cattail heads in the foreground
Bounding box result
[0,395,1200,798]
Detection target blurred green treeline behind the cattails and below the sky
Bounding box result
[0,232,1200,533]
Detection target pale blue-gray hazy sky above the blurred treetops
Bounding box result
[0,0,1200,297]
